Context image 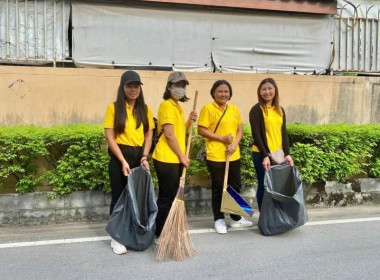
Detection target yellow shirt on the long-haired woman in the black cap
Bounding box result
[104,103,154,147]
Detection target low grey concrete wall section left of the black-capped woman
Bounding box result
[0,191,111,226]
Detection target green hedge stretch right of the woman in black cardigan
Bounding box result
[288,124,380,183]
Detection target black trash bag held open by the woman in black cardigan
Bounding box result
[258,164,308,235]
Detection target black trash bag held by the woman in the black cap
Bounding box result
[106,166,158,251]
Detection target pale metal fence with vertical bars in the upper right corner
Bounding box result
[332,0,380,72]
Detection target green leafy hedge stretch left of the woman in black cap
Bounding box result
[0,125,110,195]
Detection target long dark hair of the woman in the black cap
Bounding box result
[114,81,149,134]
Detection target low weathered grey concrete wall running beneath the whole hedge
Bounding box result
[0,179,380,226]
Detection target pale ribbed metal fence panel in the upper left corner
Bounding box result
[0,0,71,65]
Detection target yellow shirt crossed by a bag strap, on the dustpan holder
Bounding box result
[198,102,242,162]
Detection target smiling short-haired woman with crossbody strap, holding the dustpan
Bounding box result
[198,80,253,234]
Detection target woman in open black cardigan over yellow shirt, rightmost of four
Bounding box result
[249,78,294,210]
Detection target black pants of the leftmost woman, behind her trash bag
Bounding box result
[108,145,142,215]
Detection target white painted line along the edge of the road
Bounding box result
[0,217,380,249]
